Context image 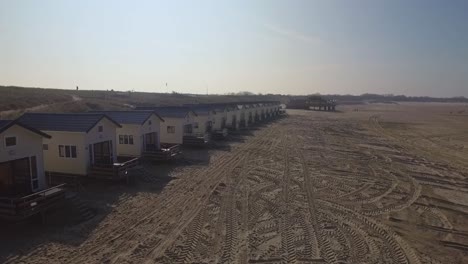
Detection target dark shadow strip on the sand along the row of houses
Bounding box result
[0,125,263,263]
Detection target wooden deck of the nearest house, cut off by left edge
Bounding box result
[0,184,65,221]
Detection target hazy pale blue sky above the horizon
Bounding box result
[0,0,468,96]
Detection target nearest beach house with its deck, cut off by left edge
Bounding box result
[0,120,65,220]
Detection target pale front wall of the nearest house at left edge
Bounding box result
[0,124,47,191]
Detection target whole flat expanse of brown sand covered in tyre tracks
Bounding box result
[0,103,468,263]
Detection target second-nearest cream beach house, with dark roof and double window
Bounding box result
[18,113,132,179]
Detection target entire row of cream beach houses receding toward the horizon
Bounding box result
[0,101,281,219]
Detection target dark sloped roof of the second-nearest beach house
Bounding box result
[18,113,120,132]
